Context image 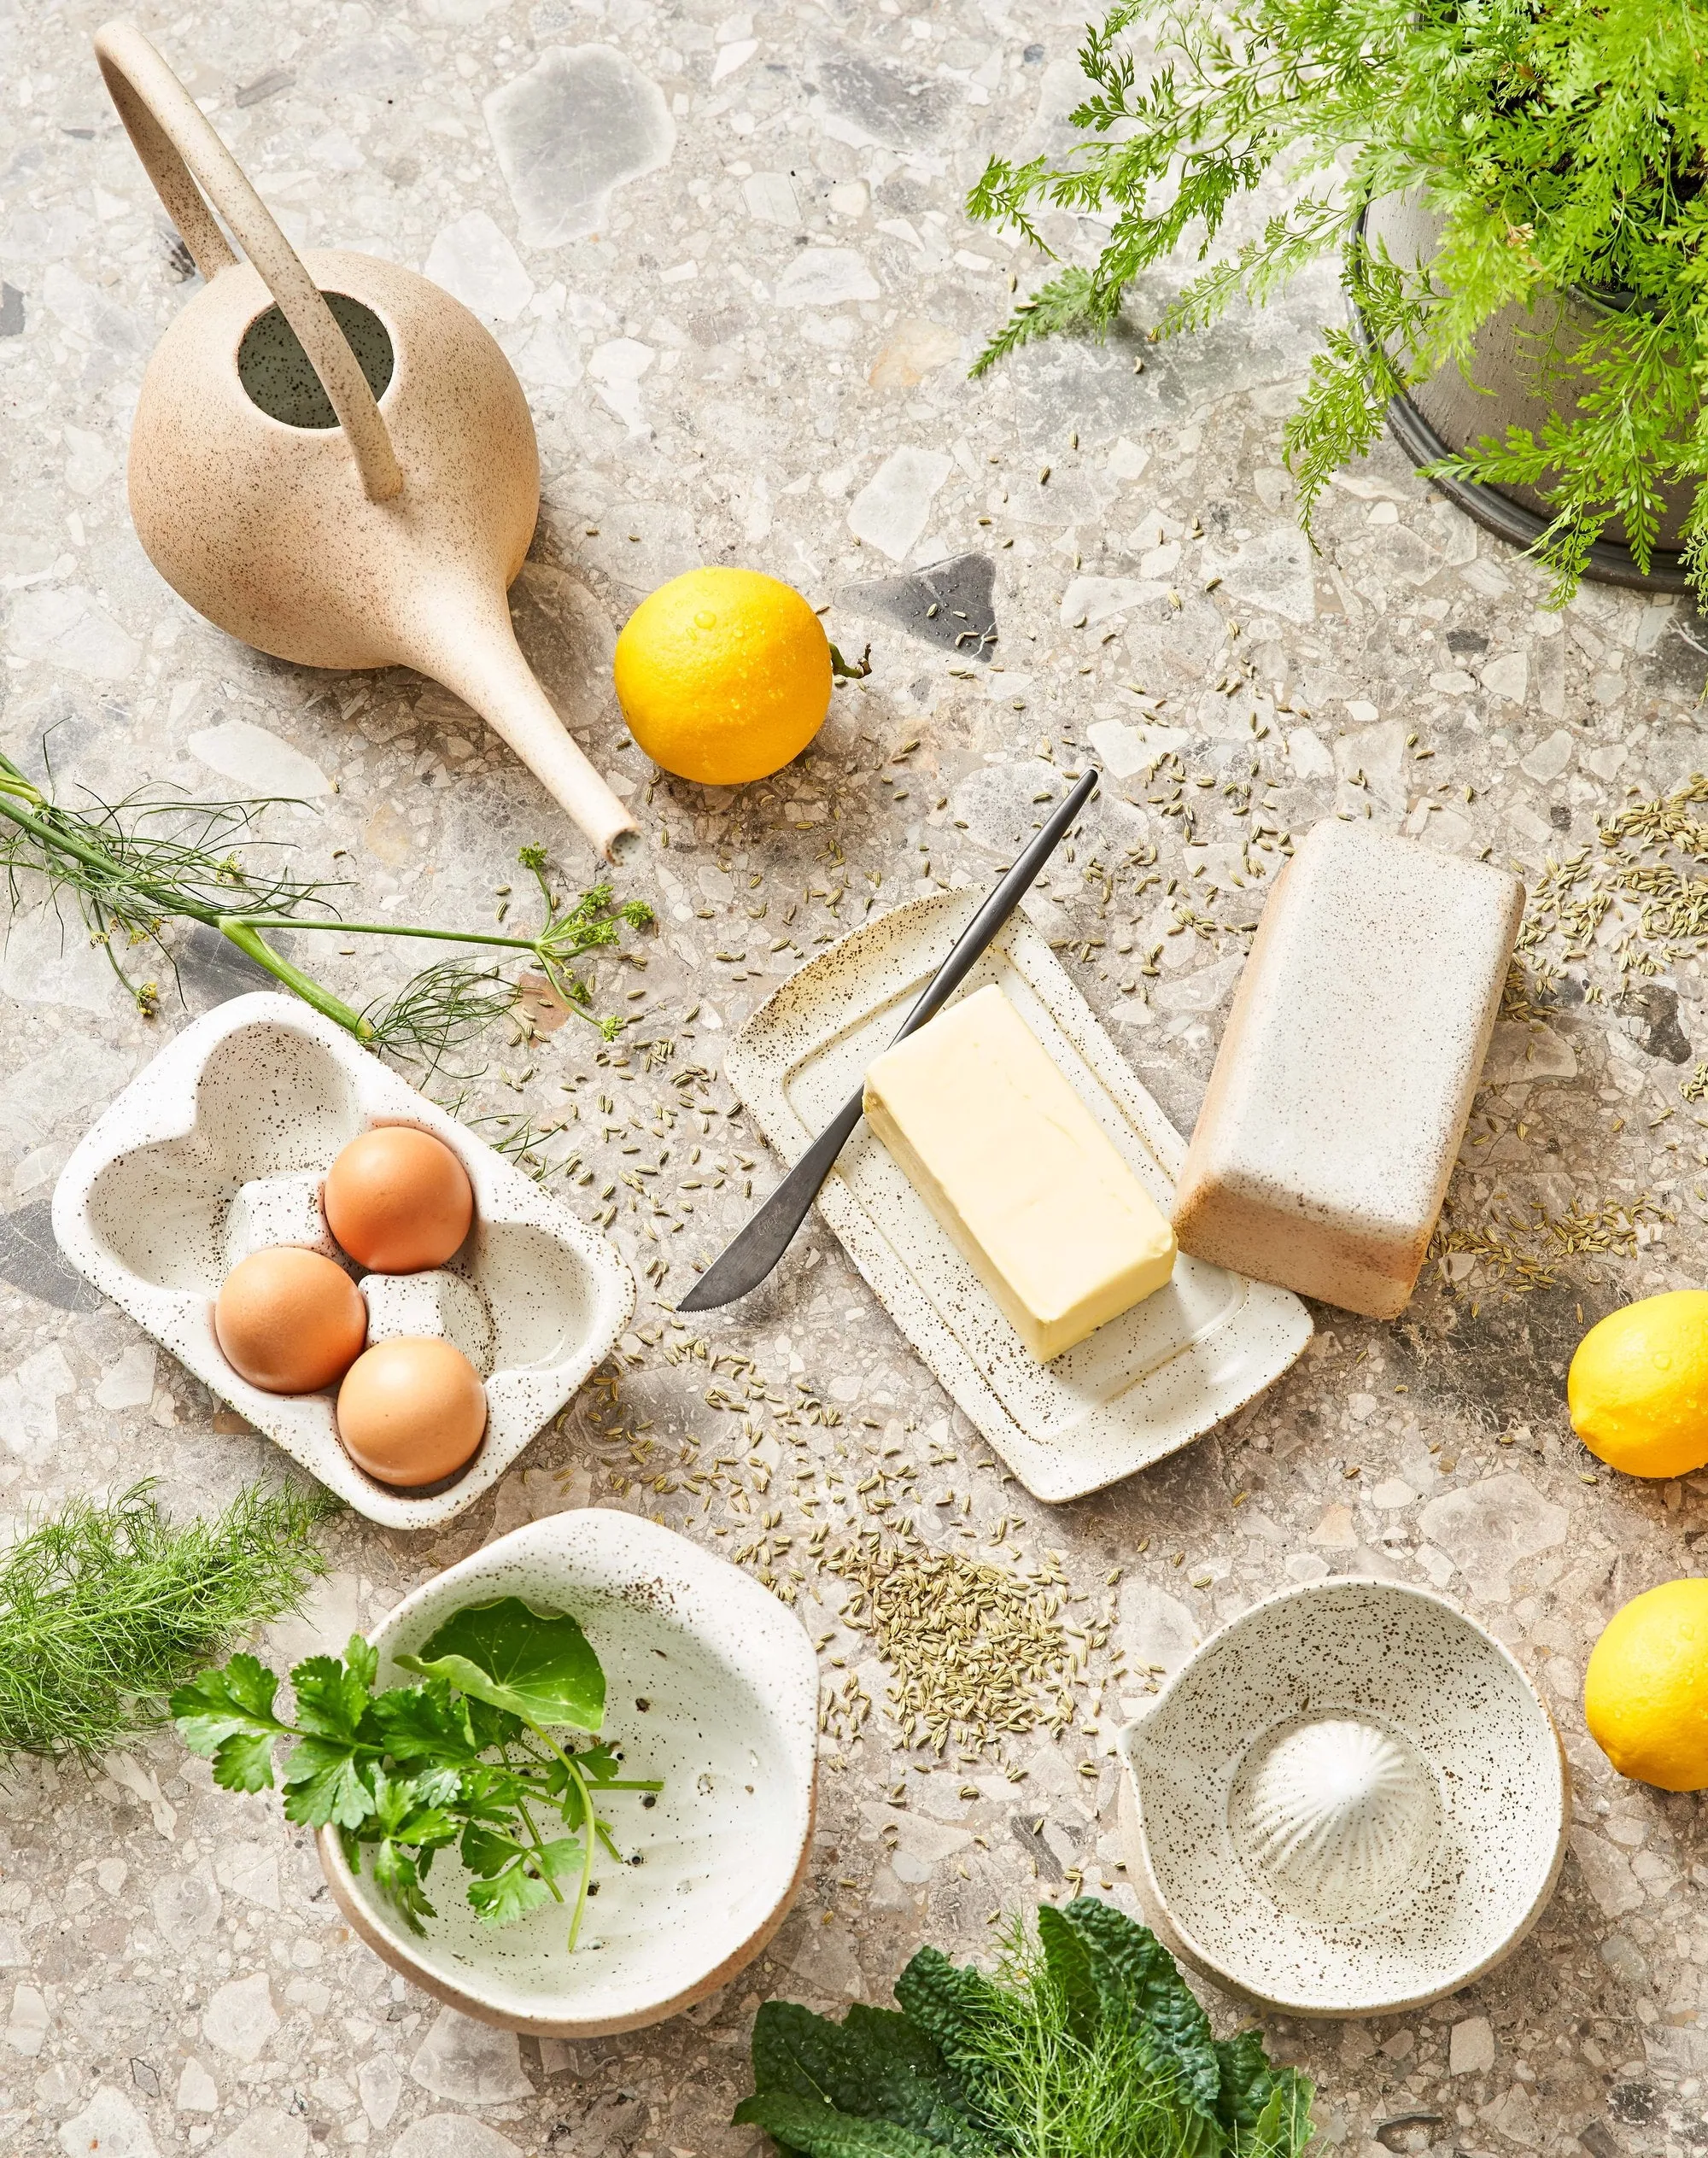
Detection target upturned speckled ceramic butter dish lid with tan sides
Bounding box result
[1173,822,1524,1319]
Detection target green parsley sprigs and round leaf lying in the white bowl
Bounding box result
[173,1597,663,1949]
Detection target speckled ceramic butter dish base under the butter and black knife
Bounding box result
[723,892,1311,1504]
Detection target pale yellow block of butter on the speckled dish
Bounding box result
[866,986,1174,1364]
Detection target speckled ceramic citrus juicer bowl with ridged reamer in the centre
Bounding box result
[1120,1580,1570,2015]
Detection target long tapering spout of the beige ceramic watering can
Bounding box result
[408,591,637,861]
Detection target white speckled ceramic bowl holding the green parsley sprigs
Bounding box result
[319,1508,818,2039]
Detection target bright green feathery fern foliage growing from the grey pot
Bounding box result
[969,0,1708,600]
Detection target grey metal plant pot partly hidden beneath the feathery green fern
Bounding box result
[1358,194,1693,591]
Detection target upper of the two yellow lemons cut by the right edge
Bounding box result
[1565,1289,1708,1476]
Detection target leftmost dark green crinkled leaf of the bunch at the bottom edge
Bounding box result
[753,2001,985,2158]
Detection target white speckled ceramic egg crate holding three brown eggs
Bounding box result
[54,995,635,1528]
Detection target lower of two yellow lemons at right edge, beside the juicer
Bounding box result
[1582,1579,1708,1791]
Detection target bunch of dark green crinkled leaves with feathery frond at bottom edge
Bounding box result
[736,1897,1311,2158]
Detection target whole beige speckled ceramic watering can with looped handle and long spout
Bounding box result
[95,21,635,859]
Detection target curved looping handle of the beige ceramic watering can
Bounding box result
[95,21,404,503]
